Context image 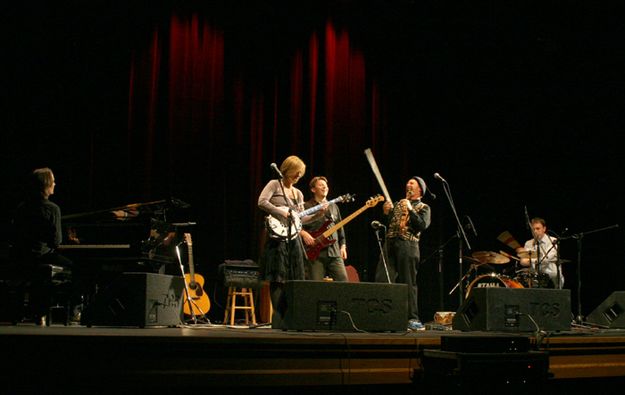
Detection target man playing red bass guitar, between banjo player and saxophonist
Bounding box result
[300,176,347,281]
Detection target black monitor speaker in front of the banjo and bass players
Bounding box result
[280,281,408,332]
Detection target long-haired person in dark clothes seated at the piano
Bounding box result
[11,167,80,323]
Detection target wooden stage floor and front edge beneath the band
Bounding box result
[0,324,625,394]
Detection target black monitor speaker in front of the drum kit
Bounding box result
[452,287,572,332]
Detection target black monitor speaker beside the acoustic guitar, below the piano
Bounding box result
[81,272,184,327]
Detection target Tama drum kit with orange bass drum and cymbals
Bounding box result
[461,251,553,298]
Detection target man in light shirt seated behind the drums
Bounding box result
[516,217,564,289]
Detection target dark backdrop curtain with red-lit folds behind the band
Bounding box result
[1,0,625,320]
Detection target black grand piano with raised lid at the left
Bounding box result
[58,199,194,292]
